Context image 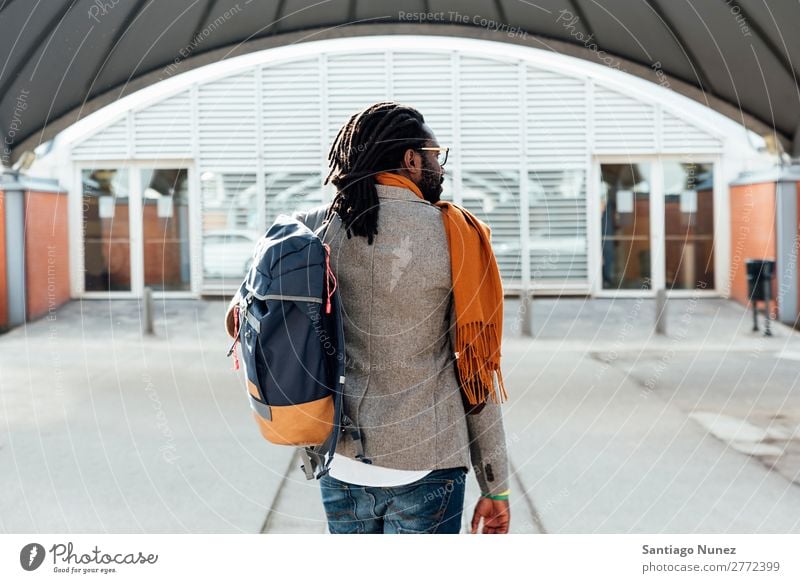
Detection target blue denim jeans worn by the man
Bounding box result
[320,467,467,534]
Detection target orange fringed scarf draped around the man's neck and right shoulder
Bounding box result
[375,172,508,405]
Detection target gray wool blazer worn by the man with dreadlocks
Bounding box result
[294,185,509,494]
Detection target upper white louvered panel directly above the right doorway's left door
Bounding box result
[594,86,656,154]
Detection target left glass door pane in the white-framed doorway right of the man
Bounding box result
[599,162,652,290]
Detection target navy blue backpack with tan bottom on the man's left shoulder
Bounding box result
[226,210,362,480]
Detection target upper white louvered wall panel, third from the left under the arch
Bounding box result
[197,71,257,166]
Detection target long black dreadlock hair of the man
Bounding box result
[323,101,430,245]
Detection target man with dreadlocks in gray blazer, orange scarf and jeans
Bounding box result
[295,102,509,533]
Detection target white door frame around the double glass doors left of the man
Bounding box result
[70,159,202,299]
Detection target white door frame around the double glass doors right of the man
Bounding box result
[586,154,728,299]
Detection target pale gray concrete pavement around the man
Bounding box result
[0,298,800,533]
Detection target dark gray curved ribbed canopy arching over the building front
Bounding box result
[0,0,800,165]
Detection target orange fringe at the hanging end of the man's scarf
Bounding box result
[456,322,508,405]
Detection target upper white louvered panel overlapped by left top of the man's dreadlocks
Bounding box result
[326,52,389,138]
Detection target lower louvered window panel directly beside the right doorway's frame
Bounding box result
[528,170,589,285]
